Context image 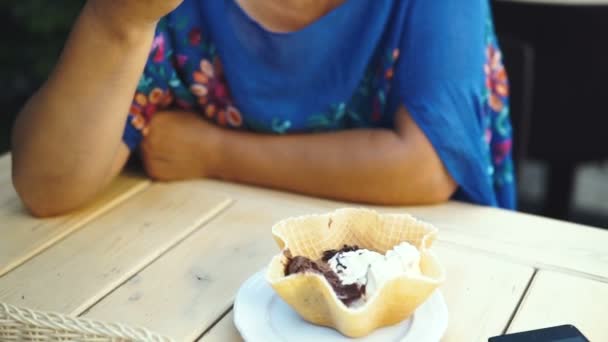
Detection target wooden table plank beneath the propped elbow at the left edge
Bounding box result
[0,155,149,277]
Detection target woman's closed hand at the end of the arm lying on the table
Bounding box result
[141,112,224,181]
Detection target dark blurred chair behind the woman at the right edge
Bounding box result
[493,1,608,219]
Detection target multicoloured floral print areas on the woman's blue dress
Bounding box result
[125,8,514,208]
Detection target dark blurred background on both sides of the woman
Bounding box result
[0,0,608,228]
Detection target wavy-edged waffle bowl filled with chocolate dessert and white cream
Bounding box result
[266,209,445,337]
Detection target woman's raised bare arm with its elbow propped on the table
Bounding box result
[12,0,181,216]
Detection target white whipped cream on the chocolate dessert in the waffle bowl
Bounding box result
[327,242,421,304]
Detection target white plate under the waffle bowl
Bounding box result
[234,271,448,342]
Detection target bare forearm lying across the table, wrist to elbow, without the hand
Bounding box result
[215,109,456,205]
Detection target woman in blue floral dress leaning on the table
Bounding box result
[13,0,514,216]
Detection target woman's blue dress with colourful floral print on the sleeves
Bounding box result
[124,0,515,208]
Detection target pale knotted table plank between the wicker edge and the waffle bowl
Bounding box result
[85,197,326,341]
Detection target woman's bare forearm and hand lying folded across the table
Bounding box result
[142,108,456,205]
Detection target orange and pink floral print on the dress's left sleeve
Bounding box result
[127,20,244,147]
